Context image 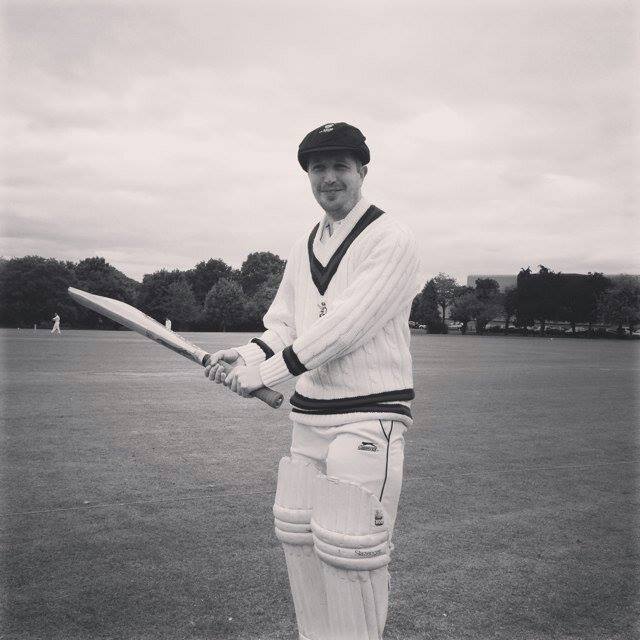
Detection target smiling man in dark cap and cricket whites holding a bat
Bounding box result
[205,122,418,640]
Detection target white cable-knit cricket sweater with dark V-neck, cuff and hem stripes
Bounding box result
[238,199,419,426]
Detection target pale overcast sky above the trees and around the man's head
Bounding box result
[0,0,640,281]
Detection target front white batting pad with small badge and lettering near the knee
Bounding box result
[311,476,390,640]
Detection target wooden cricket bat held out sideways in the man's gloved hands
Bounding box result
[69,287,284,409]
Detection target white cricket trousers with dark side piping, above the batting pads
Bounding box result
[291,420,406,535]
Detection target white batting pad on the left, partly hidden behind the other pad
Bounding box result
[273,457,331,640]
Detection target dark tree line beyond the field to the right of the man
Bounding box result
[411,265,640,335]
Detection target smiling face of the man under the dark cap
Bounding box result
[307,151,367,220]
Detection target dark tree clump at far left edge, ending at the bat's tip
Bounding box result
[0,256,78,329]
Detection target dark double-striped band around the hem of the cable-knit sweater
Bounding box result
[289,389,415,417]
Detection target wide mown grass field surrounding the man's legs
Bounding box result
[0,330,640,640]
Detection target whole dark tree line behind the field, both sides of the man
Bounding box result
[0,251,640,334]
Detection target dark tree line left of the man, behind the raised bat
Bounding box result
[0,251,285,331]
